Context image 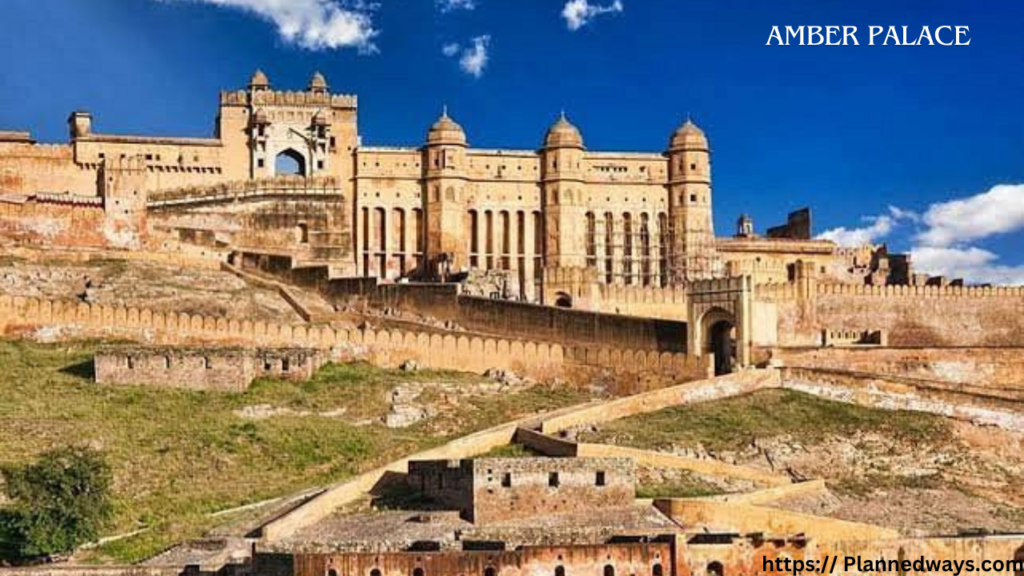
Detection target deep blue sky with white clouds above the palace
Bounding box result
[0,0,1024,283]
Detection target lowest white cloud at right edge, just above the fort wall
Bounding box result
[910,246,1024,285]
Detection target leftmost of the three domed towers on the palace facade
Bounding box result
[421,108,469,279]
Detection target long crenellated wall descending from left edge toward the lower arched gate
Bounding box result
[0,296,708,381]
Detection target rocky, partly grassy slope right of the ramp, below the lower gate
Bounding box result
[575,393,1024,535]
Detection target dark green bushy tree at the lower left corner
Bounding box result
[0,448,113,558]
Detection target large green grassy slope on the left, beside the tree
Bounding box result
[0,342,589,562]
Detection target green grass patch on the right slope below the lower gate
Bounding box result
[582,390,952,451]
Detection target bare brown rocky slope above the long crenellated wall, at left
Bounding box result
[0,258,299,322]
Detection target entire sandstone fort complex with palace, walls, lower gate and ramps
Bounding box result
[0,72,1024,576]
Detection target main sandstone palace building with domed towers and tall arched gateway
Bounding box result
[0,72,908,306]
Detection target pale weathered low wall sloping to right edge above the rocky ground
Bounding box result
[781,368,1024,431]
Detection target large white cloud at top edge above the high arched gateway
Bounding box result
[161,0,378,52]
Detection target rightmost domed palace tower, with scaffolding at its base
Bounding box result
[667,119,722,285]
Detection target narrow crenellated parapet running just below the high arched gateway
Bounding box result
[147,175,341,208]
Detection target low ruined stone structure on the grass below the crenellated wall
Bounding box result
[94,346,326,392]
